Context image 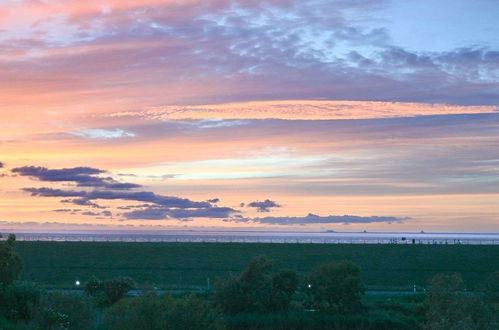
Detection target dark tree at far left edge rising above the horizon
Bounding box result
[0,234,22,288]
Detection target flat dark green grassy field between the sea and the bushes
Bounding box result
[16,242,499,290]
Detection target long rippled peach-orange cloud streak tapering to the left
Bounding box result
[109,100,499,122]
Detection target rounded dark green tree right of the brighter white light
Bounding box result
[306,261,364,313]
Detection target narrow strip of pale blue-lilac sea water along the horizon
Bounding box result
[3,230,499,245]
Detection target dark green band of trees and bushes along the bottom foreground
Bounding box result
[0,233,499,330]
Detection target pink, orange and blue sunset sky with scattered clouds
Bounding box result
[0,0,499,232]
